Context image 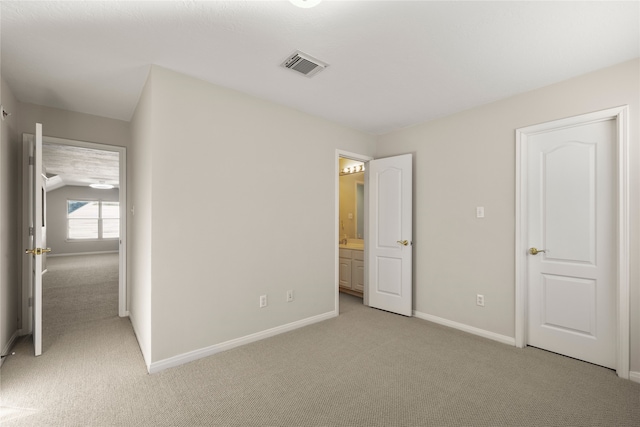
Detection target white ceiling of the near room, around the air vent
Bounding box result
[0,0,640,134]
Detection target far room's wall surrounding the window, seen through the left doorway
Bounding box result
[46,185,119,256]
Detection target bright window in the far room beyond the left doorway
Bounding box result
[67,200,120,240]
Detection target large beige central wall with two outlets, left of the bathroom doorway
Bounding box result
[132,67,374,362]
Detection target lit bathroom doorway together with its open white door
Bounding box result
[335,150,413,316]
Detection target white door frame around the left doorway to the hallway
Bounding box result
[20,133,129,335]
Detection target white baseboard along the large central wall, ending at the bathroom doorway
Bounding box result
[149,311,338,374]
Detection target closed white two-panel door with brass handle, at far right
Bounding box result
[527,120,616,368]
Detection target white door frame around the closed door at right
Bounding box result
[515,105,630,379]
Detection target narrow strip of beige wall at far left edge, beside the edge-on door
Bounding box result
[0,76,22,363]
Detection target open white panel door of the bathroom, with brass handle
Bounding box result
[365,154,413,316]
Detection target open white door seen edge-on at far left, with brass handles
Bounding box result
[26,123,50,356]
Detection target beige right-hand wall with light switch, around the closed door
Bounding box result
[376,60,640,371]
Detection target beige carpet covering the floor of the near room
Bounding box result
[1,256,640,426]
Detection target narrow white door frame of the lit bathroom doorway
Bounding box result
[333,149,373,315]
